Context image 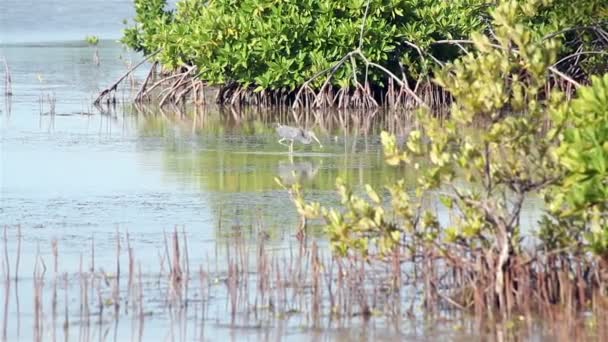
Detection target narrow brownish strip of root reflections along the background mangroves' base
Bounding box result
[131,105,420,138]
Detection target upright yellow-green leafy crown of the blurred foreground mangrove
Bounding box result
[376,1,563,253]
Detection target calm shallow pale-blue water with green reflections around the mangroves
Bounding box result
[0,0,556,341]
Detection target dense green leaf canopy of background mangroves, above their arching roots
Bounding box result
[123,0,485,89]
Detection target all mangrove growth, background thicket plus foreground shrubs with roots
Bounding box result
[89,0,608,332]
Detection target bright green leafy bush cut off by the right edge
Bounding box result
[542,74,608,260]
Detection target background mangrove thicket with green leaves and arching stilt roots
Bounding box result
[96,0,608,108]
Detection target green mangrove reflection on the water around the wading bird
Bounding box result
[134,107,418,193]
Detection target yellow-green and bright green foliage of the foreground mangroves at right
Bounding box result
[296,1,608,264]
